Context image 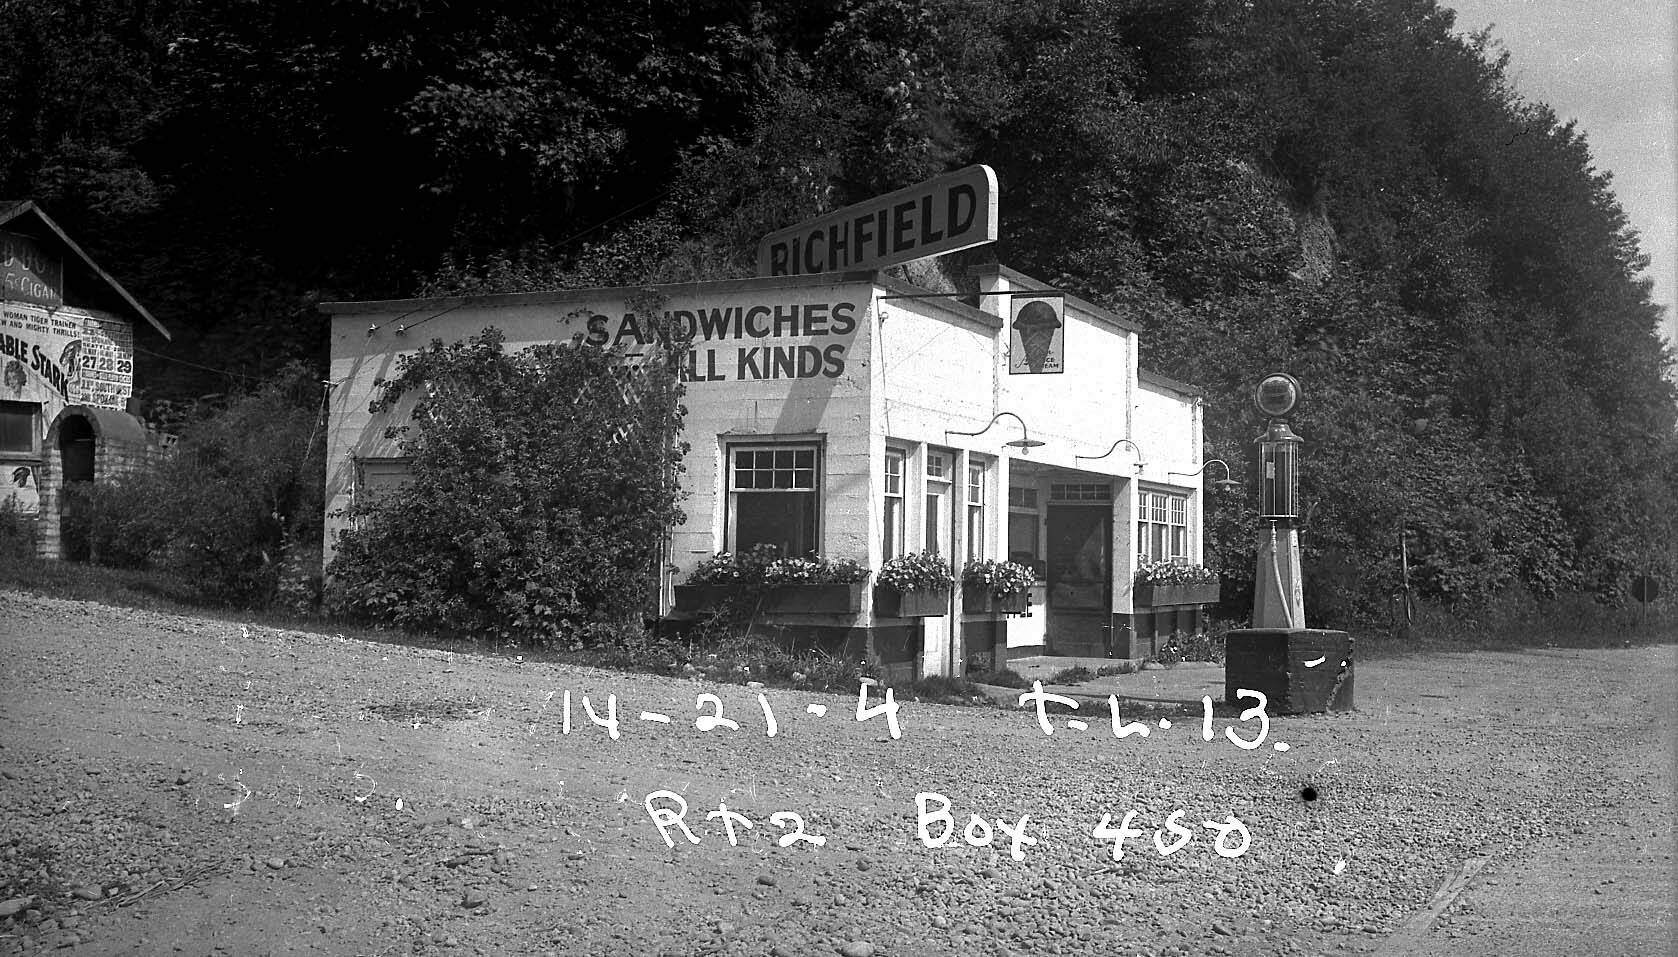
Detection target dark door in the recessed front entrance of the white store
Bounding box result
[1045,504,1113,656]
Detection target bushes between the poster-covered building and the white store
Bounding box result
[62,366,324,606]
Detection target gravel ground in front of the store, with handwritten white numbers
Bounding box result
[0,593,1678,957]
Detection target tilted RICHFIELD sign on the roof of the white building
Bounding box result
[757,166,997,275]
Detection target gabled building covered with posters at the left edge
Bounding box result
[0,200,169,557]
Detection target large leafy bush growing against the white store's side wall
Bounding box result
[327,324,685,645]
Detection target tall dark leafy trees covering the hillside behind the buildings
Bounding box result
[0,0,1678,616]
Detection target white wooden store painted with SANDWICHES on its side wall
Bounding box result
[322,267,1201,675]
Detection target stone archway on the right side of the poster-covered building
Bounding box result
[35,405,163,559]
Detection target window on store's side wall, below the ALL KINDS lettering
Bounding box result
[728,445,821,556]
